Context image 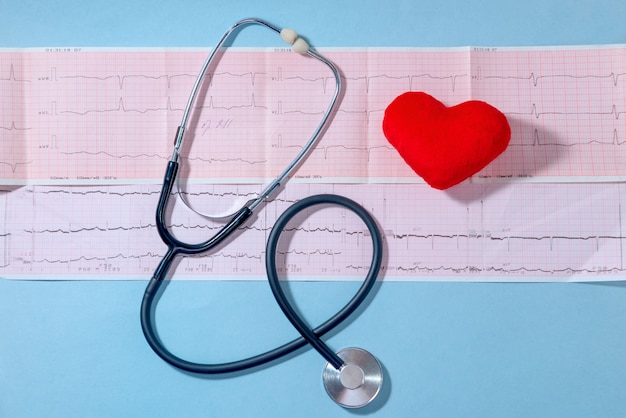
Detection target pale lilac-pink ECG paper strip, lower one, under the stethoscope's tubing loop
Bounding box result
[0,183,626,281]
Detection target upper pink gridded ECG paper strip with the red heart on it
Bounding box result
[0,45,626,185]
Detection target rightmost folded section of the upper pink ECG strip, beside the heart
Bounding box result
[473,47,626,181]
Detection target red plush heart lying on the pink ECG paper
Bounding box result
[383,92,511,190]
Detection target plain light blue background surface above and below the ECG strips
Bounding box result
[0,0,626,418]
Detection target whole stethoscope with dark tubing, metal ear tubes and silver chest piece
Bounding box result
[141,19,383,408]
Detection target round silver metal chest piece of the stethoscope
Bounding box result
[323,348,383,408]
